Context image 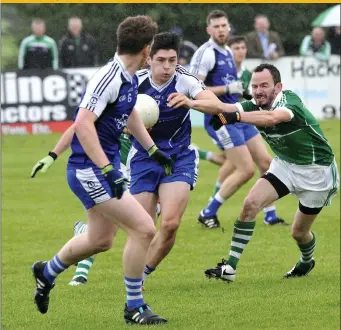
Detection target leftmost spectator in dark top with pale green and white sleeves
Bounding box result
[18,18,58,70]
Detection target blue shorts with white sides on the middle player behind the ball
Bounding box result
[128,145,199,195]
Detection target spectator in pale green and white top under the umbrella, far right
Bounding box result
[300,27,331,61]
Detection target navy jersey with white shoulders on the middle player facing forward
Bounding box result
[134,65,205,155]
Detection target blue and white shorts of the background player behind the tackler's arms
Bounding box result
[205,123,259,150]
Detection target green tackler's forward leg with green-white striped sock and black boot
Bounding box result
[205,178,280,282]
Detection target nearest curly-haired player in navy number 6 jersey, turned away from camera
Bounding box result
[32,16,173,324]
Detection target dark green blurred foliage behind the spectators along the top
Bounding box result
[2,4,330,68]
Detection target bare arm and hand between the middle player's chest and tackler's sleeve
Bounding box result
[167,90,238,115]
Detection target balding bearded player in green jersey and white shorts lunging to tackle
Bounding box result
[169,64,339,282]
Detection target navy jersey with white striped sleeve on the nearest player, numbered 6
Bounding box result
[69,54,138,166]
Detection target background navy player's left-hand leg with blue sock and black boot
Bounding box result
[198,145,255,228]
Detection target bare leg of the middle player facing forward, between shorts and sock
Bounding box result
[147,182,190,276]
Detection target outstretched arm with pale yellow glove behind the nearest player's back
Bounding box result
[31,125,75,178]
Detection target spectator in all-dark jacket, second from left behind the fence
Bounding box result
[59,17,98,68]
